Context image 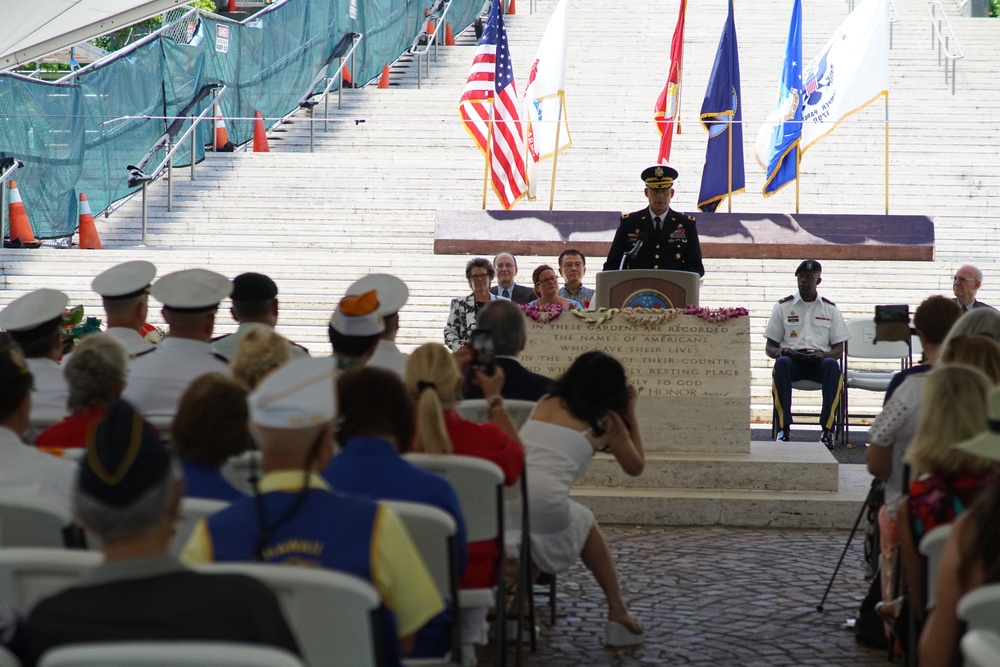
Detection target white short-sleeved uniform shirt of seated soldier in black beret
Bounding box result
[764,292,851,352]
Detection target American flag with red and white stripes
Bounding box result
[458,0,528,209]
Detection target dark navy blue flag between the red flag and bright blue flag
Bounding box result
[698,0,746,213]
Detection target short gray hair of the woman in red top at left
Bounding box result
[63,333,126,412]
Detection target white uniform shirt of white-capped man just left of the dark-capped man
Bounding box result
[122,336,231,415]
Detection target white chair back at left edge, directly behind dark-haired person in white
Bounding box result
[0,492,87,549]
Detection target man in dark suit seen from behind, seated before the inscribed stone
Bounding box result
[463,299,552,401]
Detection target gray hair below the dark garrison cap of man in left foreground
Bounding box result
[73,461,184,544]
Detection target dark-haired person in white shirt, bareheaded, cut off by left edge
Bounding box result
[0,333,76,510]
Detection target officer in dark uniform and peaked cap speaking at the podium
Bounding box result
[604,165,705,276]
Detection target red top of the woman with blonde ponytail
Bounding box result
[444,410,524,588]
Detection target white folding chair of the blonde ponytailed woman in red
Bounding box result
[406,454,507,666]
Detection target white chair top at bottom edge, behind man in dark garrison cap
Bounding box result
[38,641,305,667]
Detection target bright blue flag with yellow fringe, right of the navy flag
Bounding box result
[755,0,804,197]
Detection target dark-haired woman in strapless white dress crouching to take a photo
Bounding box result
[521,352,645,646]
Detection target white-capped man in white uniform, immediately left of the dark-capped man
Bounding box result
[122,269,233,416]
